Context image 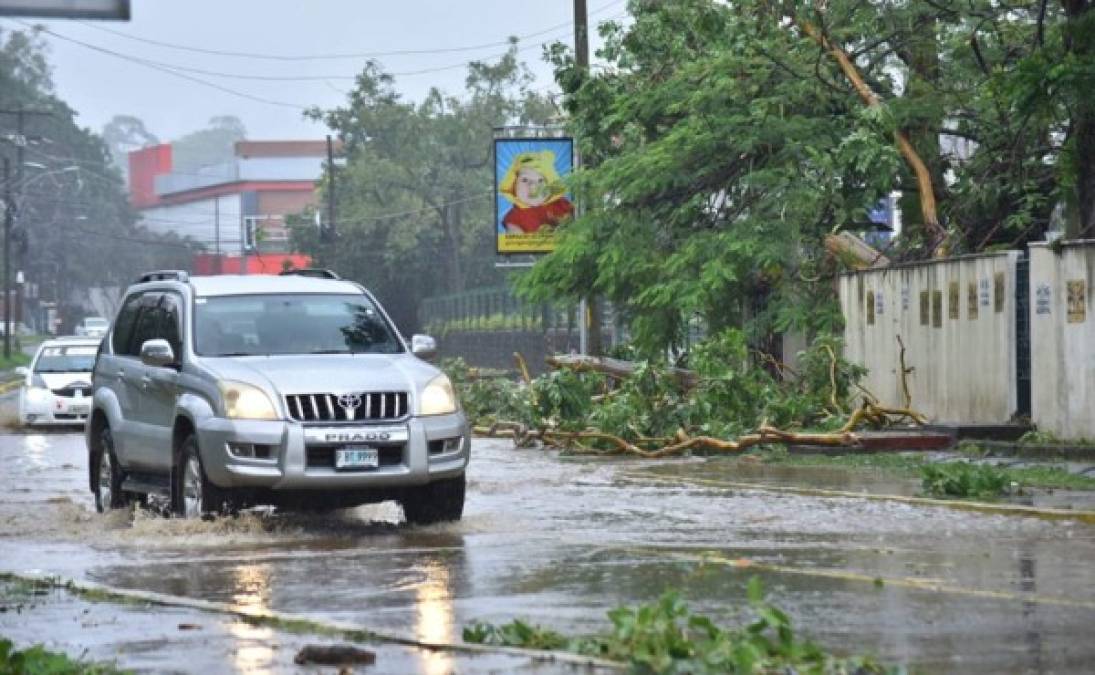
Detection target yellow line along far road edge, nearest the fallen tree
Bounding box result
[619,471,1095,525]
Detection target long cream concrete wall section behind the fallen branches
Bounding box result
[840,251,1019,424]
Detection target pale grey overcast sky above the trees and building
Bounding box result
[10,0,626,140]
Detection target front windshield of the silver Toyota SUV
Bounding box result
[194,294,403,356]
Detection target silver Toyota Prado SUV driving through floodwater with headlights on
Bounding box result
[87,271,471,523]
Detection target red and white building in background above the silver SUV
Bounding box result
[129,140,326,274]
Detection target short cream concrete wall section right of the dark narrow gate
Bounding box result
[1030,240,1095,441]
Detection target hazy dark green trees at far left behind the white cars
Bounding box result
[0,23,194,323]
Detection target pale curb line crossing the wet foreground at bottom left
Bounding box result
[0,570,627,672]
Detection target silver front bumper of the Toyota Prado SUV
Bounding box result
[197,413,471,491]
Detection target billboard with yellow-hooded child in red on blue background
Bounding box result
[494,138,574,254]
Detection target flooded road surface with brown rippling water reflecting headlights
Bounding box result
[0,420,1095,673]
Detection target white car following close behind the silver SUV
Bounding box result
[15,338,102,426]
